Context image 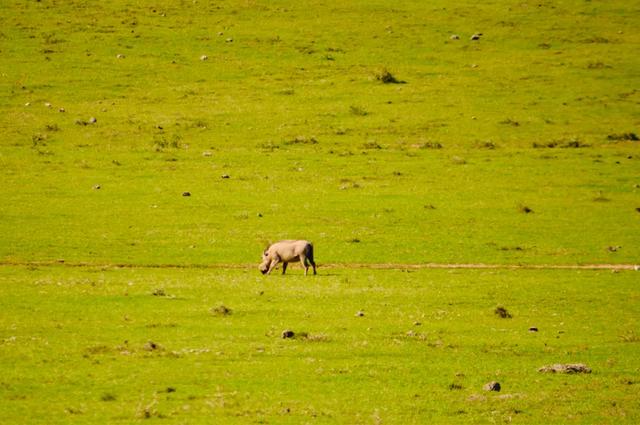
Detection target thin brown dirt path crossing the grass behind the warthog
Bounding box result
[0,260,640,270]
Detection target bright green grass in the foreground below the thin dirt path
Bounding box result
[0,267,640,423]
